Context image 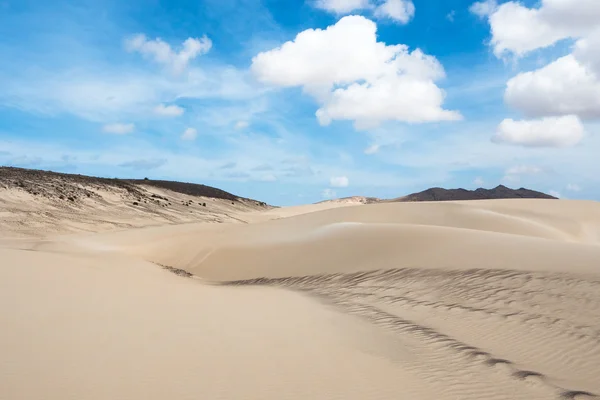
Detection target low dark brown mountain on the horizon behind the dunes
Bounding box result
[388,185,556,202]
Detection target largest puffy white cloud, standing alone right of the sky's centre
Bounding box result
[252,16,462,129]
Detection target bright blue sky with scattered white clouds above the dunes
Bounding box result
[0,0,600,205]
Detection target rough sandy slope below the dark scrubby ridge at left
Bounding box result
[0,185,265,237]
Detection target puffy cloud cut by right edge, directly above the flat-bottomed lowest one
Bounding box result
[504,55,600,118]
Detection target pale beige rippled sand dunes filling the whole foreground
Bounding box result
[0,192,600,400]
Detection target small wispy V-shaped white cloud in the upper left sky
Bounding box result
[125,34,212,73]
